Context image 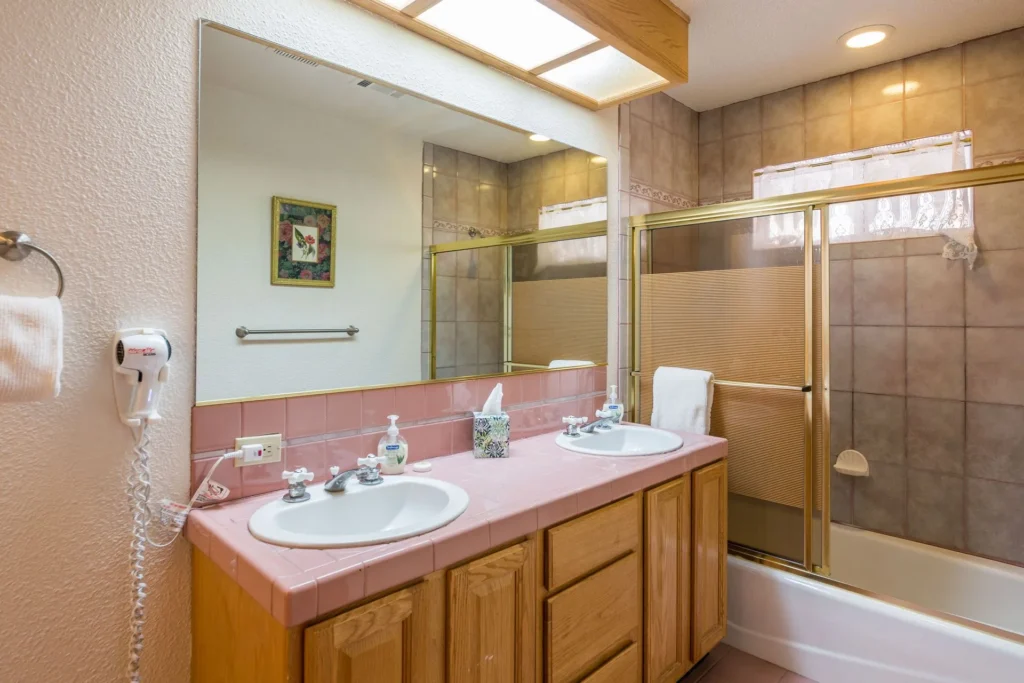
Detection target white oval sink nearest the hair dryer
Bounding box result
[249,475,469,548]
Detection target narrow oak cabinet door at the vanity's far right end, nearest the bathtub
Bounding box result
[693,461,729,660]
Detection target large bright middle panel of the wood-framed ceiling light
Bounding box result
[415,0,597,71]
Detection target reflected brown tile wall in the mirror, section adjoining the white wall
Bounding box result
[420,142,508,379]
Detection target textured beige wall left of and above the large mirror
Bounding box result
[0,0,617,683]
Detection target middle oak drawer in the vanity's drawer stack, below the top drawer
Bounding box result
[546,553,640,683]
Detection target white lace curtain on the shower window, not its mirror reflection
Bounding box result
[754,131,977,265]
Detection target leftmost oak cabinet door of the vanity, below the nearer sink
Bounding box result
[305,574,444,683]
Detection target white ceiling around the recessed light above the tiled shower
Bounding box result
[668,0,1024,112]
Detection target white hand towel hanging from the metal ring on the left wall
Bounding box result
[0,295,63,402]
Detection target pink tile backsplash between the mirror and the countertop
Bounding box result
[191,367,607,500]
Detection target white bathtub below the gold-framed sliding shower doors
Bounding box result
[725,525,1024,683]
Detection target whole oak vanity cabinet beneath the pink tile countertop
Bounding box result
[193,461,728,683]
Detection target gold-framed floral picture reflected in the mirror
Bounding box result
[270,197,338,287]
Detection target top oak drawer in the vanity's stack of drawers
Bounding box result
[546,496,640,591]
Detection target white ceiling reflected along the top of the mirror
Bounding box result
[202,26,567,164]
